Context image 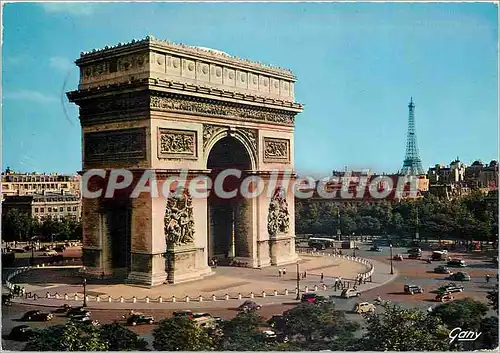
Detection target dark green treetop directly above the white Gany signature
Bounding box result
[431,298,488,331]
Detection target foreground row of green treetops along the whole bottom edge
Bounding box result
[25,299,498,351]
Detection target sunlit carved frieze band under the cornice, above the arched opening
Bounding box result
[150,96,295,125]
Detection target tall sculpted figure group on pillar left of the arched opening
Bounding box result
[164,190,194,248]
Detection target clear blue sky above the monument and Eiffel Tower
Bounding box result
[2,3,498,173]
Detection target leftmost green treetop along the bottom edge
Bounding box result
[24,323,108,351]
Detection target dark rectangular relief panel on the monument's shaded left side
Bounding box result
[84,128,146,163]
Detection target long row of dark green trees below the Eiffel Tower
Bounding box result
[295,192,498,241]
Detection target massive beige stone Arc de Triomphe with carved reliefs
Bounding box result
[67,37,302,285]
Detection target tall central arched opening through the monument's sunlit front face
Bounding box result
[207,135,252,265]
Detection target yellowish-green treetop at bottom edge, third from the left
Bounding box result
[153,317,214,351]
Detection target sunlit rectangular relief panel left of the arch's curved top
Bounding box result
[158,128,197,159]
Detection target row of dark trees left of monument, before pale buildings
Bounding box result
[2,209,82,241]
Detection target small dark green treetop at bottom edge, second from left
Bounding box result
[99,323,148,351]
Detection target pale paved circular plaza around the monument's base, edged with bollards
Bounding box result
[9,255,397,309]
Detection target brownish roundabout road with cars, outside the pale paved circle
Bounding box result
[2,245,498,350]
